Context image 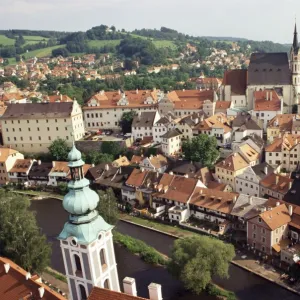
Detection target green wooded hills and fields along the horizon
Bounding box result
[0,25,290,65]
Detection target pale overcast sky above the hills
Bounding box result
[0,0,300,43]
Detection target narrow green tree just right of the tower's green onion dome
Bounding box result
[97,188,119,225]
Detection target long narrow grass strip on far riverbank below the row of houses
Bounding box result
[120,213,198,237]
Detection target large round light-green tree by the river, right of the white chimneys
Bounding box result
[168,236,235,294]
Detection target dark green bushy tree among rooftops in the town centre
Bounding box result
[182,134,219,167]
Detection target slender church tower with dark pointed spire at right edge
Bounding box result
[290,24,300,98]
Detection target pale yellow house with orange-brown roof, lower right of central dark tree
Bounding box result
[216,153,249,191]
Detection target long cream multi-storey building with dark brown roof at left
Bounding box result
[1,101,84,153]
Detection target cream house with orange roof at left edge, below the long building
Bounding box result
[0,148,24,185]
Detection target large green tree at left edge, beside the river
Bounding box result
[0,191,51,273]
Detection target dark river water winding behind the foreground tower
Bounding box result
[31,199,300,300]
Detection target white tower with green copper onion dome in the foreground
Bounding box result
[58,144,120,300]
